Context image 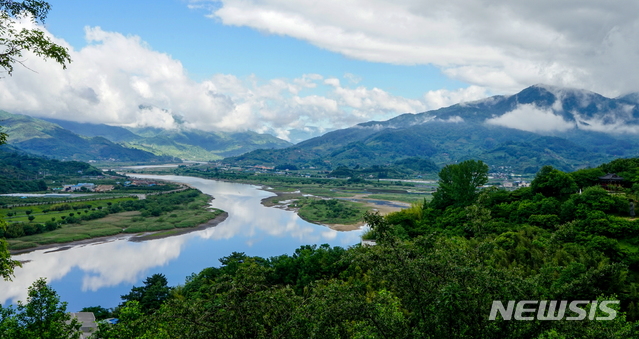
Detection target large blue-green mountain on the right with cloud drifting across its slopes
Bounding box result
[225,85,639,173]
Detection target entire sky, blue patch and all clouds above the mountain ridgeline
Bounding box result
[0,0,639,141]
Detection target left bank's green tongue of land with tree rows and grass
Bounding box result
[0,189,223,250]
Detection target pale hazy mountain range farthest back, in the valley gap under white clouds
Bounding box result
[40,119,292,161]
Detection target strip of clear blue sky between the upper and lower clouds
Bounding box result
[46,0,468,98]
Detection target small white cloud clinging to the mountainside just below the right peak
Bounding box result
[486,104,576,133]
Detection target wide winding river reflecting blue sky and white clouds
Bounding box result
[0,174,361,312]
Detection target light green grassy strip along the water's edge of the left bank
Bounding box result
[7,193,223,250]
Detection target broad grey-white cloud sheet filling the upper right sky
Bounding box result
[199,0,639,96]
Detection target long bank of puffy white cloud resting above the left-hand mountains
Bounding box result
[0,23,426,139]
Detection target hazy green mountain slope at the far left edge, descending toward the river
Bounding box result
[0,111,171,162]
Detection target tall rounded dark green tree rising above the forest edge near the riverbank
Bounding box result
[433,160,488,207]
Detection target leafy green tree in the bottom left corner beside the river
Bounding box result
[0,279,82,339]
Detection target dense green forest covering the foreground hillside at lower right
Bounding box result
[7,158,639,339]
